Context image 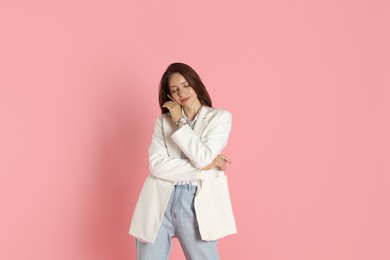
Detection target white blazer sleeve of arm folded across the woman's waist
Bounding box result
[149,116,199,182]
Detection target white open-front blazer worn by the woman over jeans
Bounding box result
[129,106,237,243]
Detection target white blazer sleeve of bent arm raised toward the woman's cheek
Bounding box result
[171,109,232,169]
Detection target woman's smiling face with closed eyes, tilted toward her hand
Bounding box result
[168,73,200,108]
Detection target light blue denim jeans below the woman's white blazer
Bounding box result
[136,184,219,260]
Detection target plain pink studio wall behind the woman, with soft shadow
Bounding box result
[0,0,390,260]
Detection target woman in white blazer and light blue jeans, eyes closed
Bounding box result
[130,63,237,260]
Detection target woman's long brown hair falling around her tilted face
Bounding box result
[158,62,212,114]
